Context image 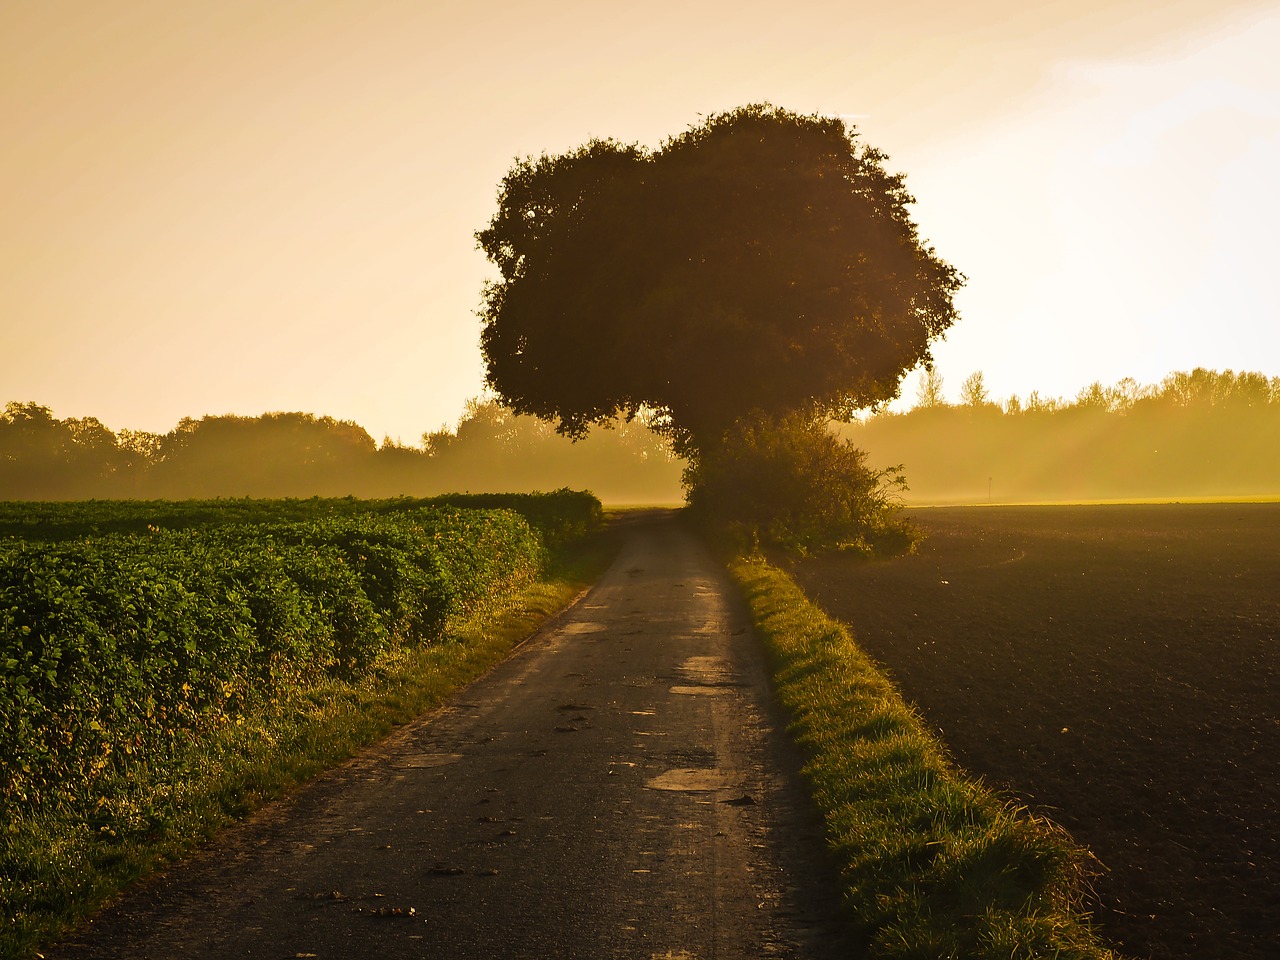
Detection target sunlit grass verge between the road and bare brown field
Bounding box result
[731,559,1116,960]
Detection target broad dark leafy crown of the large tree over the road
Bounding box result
[477,105,963,456]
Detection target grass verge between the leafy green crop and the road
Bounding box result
[0,535,613,960]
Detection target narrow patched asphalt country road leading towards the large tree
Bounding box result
[46,513,852,960]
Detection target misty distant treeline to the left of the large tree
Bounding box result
[0,401,684,503]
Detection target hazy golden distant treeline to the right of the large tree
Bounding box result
[840,369,1280,503]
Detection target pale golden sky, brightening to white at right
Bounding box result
[0,0,1280,444]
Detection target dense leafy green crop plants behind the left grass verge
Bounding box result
[0,494,599,810]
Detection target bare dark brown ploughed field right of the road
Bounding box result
[794,504,1280,960]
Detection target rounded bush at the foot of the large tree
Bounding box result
[686,413,915,554]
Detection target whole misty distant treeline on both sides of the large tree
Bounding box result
[0,370,1280,504]
